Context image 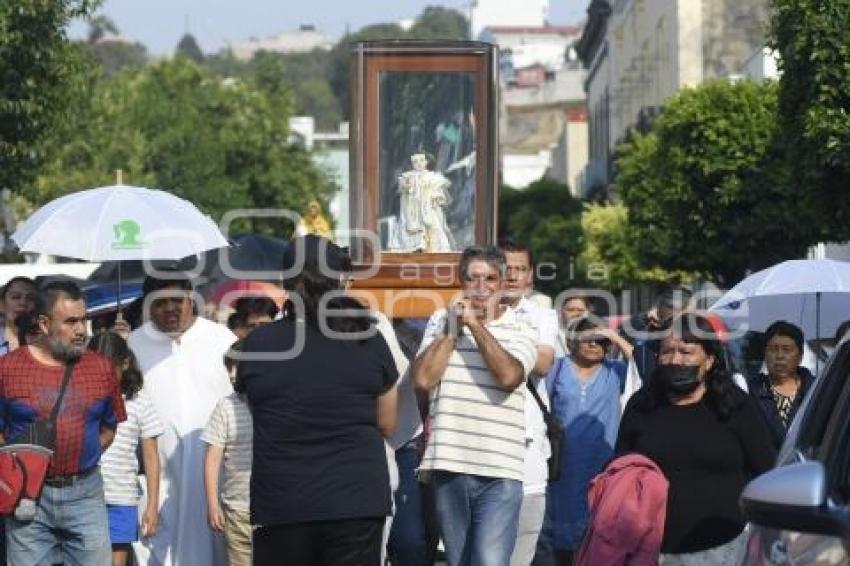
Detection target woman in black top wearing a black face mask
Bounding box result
[617,313,776,566]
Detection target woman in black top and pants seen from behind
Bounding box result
[237,236,398,566]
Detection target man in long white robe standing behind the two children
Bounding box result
[128,277,236,566]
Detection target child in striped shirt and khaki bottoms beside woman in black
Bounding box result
[201,342,254,566]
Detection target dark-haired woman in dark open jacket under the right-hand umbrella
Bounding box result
[747,320,815,450]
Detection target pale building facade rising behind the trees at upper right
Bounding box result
[576,0,767,193]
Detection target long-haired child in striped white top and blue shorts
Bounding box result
[89,331,163,566]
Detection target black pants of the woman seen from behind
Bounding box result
[253,517,385,566]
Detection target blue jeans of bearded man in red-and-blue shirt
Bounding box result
[6,470,112,566]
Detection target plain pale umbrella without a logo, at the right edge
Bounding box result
[709,259,850,339]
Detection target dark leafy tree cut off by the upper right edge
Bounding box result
[770,0,850,240]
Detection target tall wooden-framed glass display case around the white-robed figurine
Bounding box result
[350,41,498,263]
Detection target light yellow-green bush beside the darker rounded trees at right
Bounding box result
[576,203,693,291]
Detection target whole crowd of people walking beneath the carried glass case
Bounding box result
[0,235,840,566]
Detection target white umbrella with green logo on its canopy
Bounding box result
[12,184,228,318]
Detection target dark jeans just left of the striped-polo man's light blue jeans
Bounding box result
[388,442,434,566]
